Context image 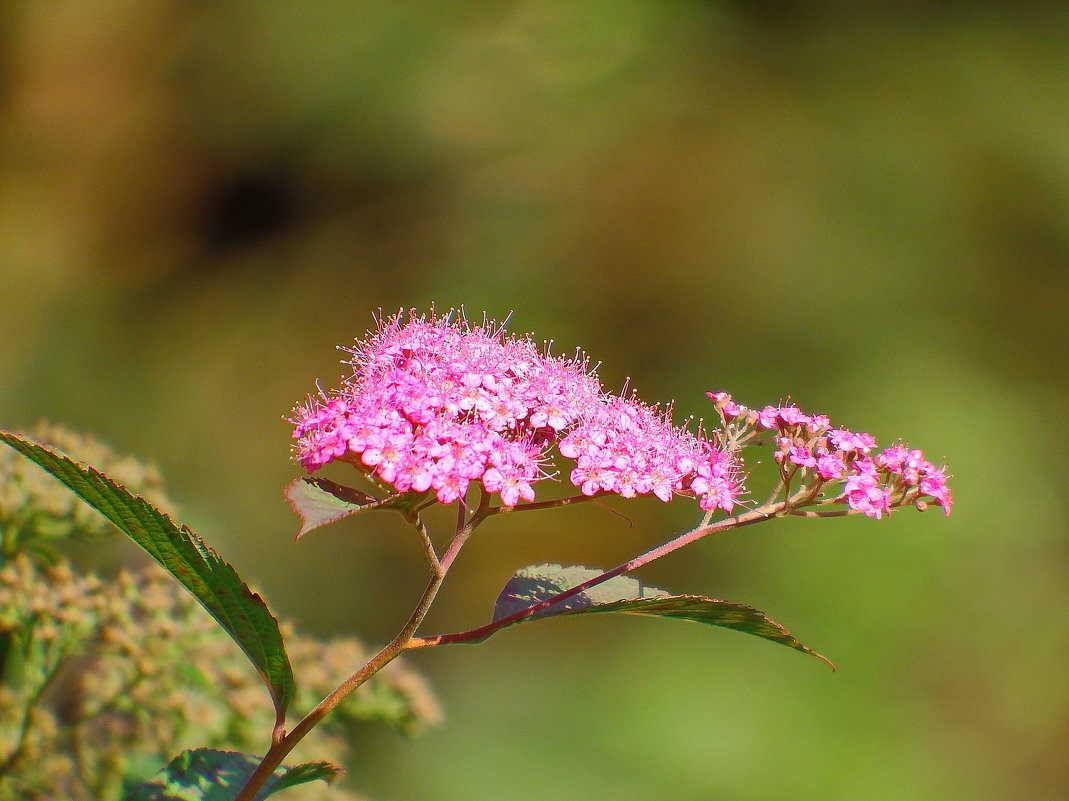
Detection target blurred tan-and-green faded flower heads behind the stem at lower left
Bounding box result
[0,429,440,801]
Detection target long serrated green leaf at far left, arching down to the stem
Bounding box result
[0,431,294,721]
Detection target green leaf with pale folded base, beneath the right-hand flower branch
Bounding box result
[494,565,835,671]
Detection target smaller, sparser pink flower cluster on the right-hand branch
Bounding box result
[708,392,952,519]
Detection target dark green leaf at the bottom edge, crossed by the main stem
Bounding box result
[125,749,342,801]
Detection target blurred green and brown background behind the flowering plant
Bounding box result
[0,0,1069,801]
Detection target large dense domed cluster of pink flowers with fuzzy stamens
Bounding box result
[290,312,742,511]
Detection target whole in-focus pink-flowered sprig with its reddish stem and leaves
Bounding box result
[0,312,952,801]
